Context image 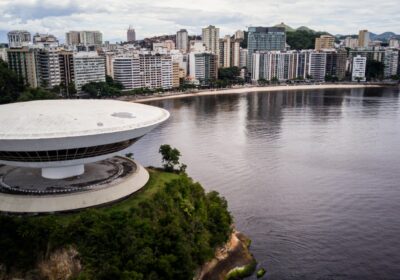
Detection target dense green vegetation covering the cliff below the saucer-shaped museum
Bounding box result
[0,170,232,280]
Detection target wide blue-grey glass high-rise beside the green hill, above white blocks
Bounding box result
[247,27,286,70]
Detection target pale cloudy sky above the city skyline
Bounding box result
[0,0,400,42]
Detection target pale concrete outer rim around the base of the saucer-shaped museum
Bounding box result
[0,159,150,214]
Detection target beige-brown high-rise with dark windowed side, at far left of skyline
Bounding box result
[7,47,39,87]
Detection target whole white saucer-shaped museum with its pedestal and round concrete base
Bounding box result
[0,100,169,213]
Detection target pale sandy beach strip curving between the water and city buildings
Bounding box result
[120,84,385,103]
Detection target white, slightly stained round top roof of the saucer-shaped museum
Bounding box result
[0,100,169,141]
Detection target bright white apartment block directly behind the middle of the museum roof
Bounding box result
[73,52,106,92]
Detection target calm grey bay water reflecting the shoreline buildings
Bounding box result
[130,89,400,279]
